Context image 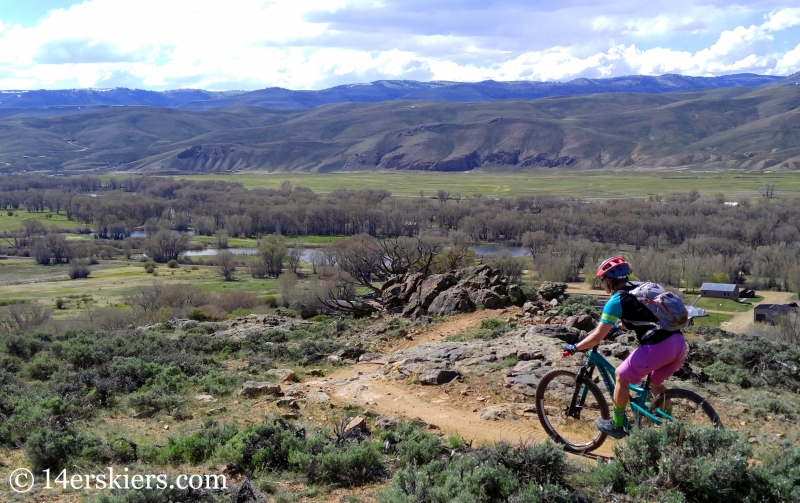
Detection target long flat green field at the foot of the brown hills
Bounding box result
[176,170,800,199]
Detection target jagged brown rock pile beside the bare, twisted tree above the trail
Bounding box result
[381,265,524,318]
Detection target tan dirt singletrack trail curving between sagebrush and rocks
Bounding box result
[304,308,613,456]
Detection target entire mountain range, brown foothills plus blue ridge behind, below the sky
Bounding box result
[0,75,800,174]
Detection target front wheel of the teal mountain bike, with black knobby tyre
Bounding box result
[536,370,611,453]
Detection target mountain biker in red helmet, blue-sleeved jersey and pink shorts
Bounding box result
[564,257,686,439]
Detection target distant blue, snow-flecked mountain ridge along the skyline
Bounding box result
[0,74,784,117]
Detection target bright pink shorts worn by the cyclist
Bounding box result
[617,332,686,384]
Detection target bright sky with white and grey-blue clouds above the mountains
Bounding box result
[0,0,800,90]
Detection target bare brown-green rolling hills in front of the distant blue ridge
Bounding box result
[0,83,800,173]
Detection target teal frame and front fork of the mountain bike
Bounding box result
[566,347,674,433]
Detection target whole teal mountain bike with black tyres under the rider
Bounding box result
[536,332,722,454]
